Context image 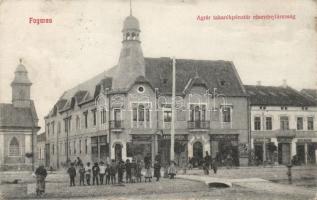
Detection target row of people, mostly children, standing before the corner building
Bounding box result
[67,156,176,186]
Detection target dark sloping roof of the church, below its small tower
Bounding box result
[0,103,37,128]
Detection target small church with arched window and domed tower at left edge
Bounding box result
[0,60,40,170]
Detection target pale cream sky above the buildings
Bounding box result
[0,0,317,131]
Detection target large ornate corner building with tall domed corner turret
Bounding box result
[45,12,251,168]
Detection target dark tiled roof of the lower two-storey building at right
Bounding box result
[244,85,316,107]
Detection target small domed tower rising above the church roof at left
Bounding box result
[11,59,32,107]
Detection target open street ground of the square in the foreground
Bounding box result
[0,167,317,200]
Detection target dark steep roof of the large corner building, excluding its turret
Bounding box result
[50,57,246,115]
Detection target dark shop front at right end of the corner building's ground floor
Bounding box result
[210,134,239,166]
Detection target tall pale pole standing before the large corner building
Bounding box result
[171,57,176,161]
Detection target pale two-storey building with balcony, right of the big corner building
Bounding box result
[245,85,317,164]
